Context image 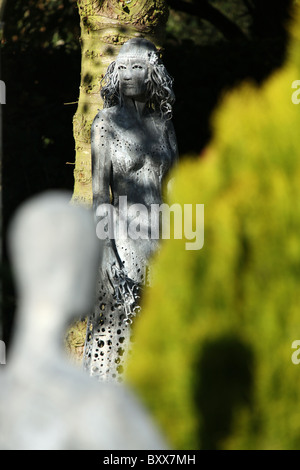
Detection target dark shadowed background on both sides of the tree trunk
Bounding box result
[1,0,292,343]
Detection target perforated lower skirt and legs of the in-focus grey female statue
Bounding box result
[83,241,154,381]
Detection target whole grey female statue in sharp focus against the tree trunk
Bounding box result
[84,38,177,379]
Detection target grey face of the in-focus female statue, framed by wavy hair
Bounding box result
[117,57,148,99]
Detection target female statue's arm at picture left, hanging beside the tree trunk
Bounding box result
[91,111,111,221]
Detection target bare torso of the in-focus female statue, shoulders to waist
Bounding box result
[110,112,172,207]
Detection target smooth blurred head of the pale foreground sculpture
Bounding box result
[8,192,101,315]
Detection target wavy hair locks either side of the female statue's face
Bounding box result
[101,51,175,120]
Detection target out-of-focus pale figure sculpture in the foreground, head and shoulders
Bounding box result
[0,192,166,450]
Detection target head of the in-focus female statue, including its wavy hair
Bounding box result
[101,38,175,119]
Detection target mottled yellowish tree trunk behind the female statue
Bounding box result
[72,0,168,205]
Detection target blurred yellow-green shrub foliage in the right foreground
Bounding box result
[128,6,300,449]
